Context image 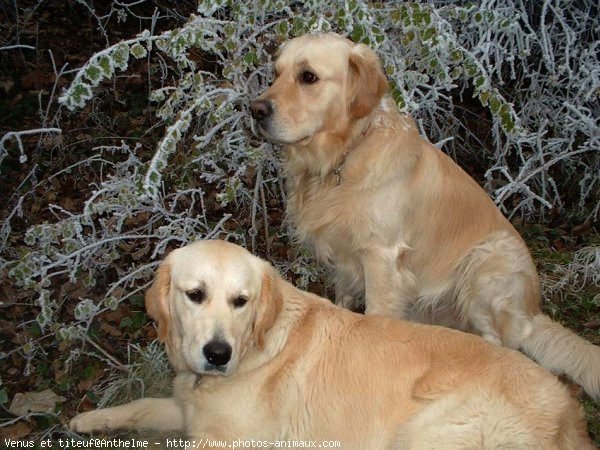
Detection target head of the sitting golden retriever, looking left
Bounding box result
[250,33,388,145]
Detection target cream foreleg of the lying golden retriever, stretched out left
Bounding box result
[69,398,184,433]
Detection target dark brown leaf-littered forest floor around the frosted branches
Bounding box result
[0,1,600,445]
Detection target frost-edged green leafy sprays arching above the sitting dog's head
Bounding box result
[60,0,536,204]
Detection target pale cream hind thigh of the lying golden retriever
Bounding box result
[392,385,594,450]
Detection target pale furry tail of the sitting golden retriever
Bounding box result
[522,314,600,401]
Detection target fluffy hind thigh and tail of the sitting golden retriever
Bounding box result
[457,232,600,400]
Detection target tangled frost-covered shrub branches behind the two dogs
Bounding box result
[5,0,600,386]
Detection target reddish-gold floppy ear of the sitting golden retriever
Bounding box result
[349,44,388,119]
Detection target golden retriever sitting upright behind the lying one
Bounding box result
[251,34,600,400]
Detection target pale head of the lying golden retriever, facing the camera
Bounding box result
[146,241,281,375]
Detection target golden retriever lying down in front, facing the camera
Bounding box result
[70,241,593,450]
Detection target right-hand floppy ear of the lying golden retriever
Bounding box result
[253,266,283,350]
